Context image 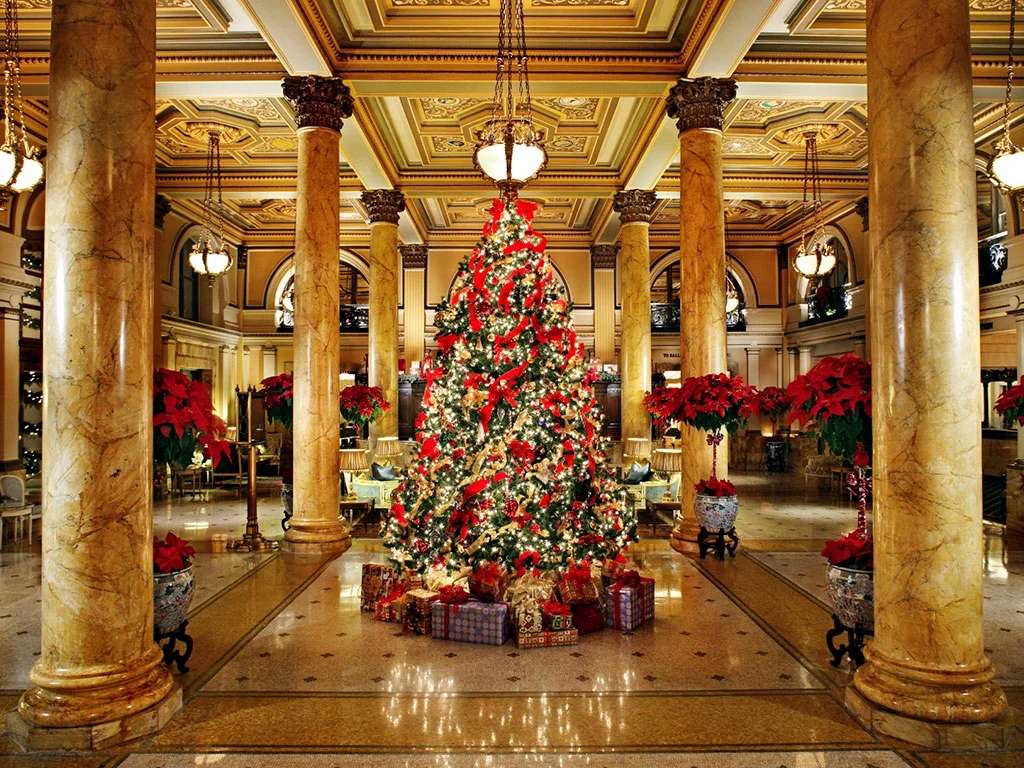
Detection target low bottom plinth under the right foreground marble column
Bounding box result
[846,685,1016,750]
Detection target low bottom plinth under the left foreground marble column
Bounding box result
[6,685,181,752]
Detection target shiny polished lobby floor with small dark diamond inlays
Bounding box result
[0,474,1024,768]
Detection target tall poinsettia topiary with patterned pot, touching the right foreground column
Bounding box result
[786,354,874,631]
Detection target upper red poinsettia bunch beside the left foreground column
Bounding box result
[153,368,227,468]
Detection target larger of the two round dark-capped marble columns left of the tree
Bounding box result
[284,75,352,553]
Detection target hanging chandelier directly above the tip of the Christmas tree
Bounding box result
[473,0,548,199]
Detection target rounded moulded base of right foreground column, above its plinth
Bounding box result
[851,651,1007,725]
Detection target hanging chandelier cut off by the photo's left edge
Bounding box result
[0,0,43,208]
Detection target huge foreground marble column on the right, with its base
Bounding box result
[847,0,1007,746]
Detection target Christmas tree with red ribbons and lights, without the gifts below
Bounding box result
[384,200,636,573]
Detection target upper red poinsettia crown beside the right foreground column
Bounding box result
[785,354,871,467]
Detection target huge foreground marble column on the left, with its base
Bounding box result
[8,0,181,750]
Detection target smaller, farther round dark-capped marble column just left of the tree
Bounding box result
[362,189,406,438]
